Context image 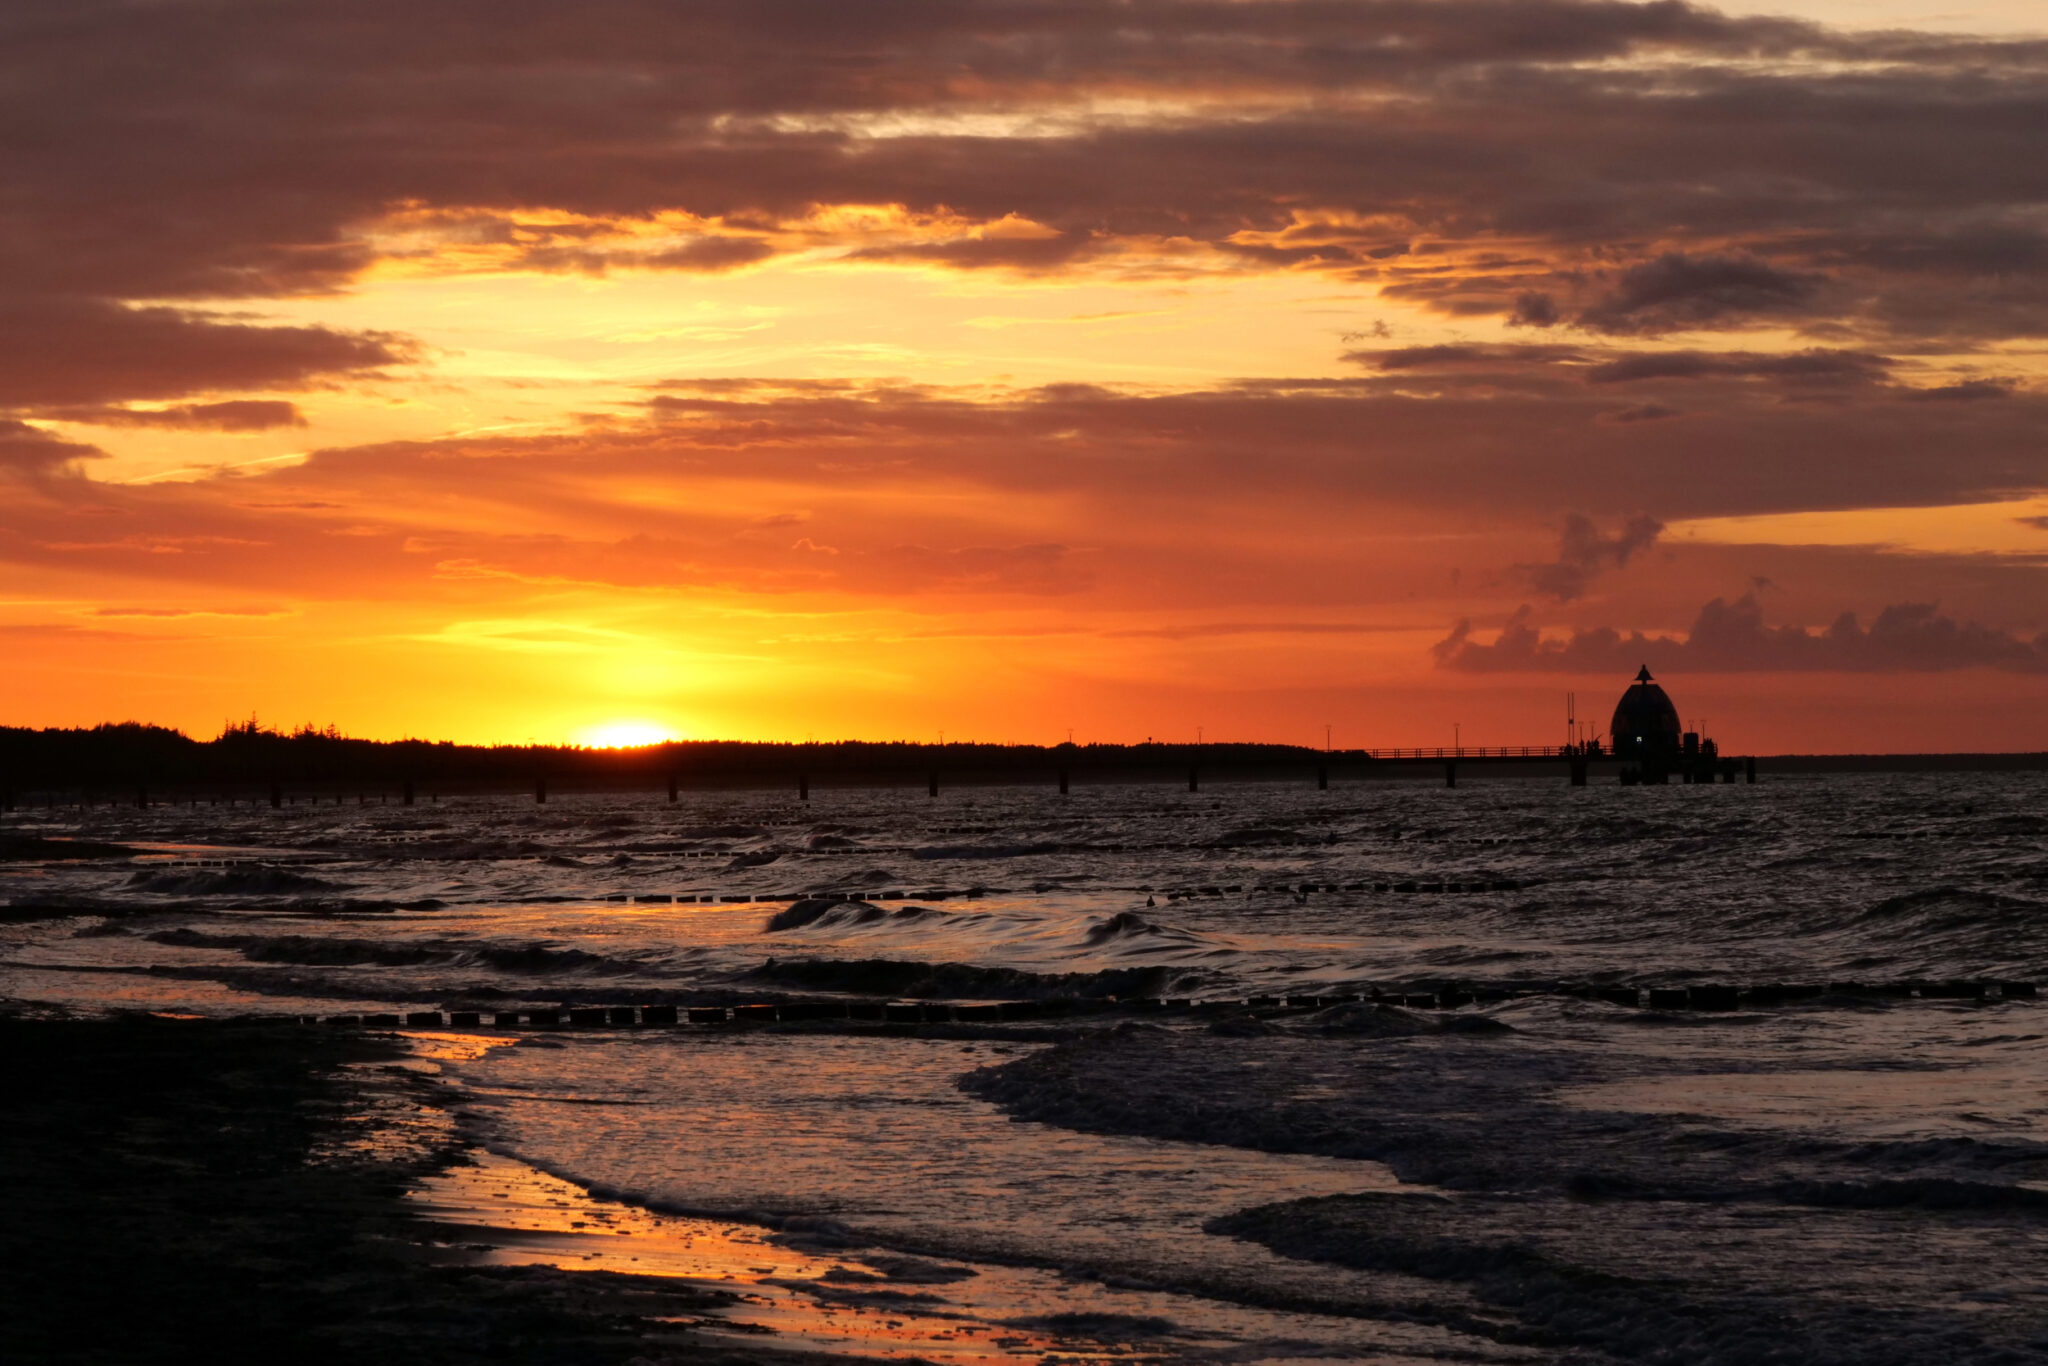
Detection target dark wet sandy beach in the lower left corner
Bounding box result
[0,1016,839,1366]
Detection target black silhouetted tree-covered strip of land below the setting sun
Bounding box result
[0,717,1329,793]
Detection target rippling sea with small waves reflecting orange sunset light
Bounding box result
[0,772,2048,1364]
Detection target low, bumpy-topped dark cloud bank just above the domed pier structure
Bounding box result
[1432,592,2048,674]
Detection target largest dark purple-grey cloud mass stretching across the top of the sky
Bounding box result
[0,0,2048,428]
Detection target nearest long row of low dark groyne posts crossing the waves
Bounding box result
[295,979,2038,1030]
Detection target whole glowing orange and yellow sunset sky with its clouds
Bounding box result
[0,0,2048,752]
